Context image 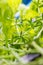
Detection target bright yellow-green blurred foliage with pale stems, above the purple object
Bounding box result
[0,0,43,64]
